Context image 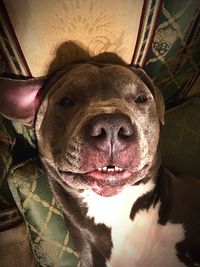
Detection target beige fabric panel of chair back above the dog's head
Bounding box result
[4,0,143,76]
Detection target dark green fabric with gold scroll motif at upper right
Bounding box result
[144,0,200,108]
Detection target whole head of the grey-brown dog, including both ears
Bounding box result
[1,63,164,196]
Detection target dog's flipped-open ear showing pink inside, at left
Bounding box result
[0,77,44,126]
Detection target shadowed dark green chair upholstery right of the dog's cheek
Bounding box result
[161,96,200,178]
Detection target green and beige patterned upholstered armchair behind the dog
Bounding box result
[0,0,200,267]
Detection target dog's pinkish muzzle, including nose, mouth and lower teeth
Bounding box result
[57,113,146,196]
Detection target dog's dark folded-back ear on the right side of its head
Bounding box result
[131,66,165,124]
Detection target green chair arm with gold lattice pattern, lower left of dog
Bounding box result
[9,159,81,267]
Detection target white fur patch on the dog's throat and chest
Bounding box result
[82,181,185,267]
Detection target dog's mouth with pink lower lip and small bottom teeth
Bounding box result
[59,165,147,197]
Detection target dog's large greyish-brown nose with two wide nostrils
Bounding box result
[86,114,135,154]
